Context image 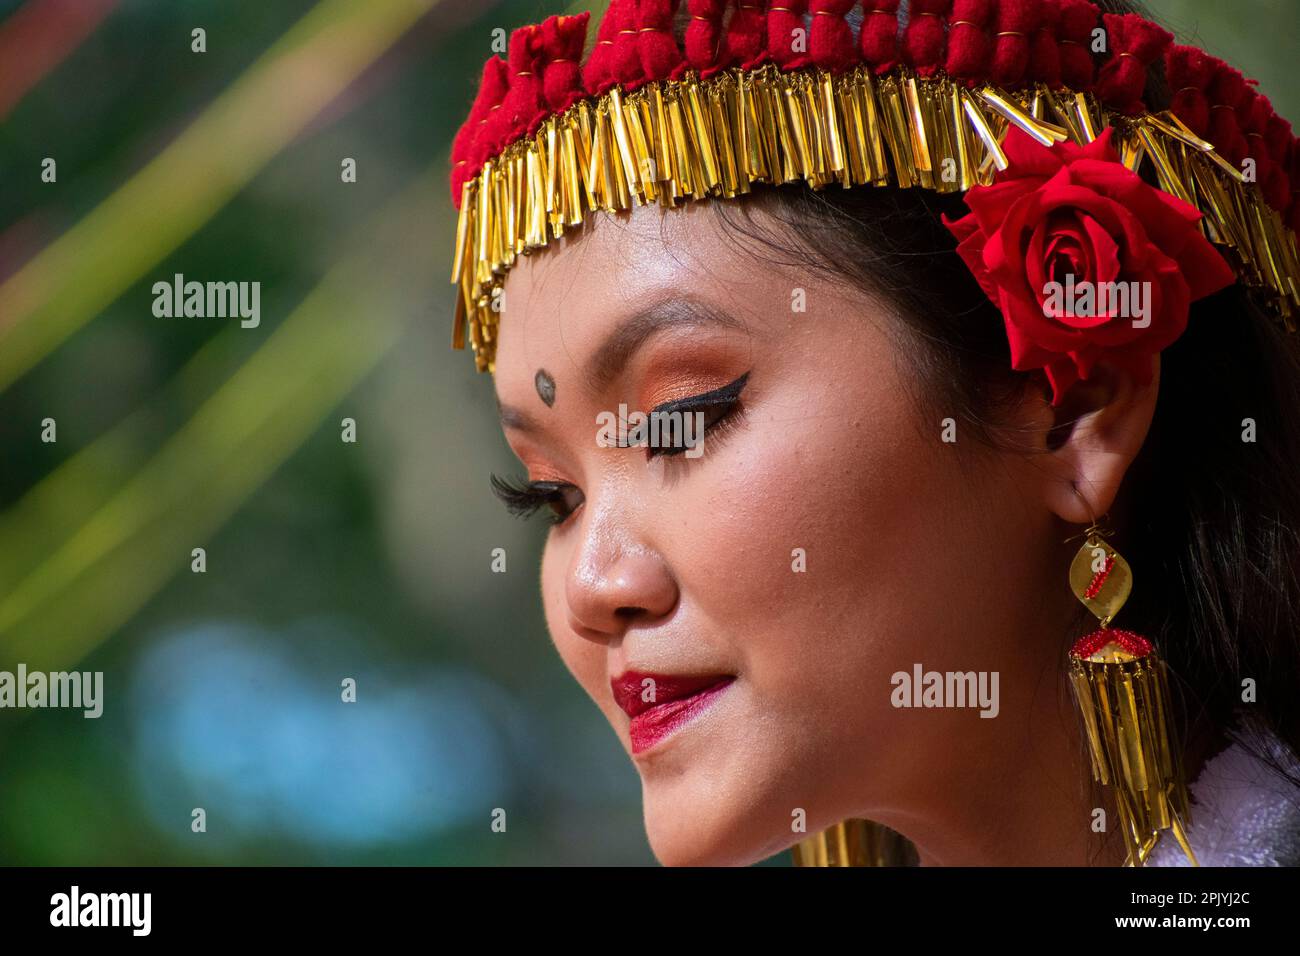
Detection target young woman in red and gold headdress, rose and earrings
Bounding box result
[452,0,1300,865]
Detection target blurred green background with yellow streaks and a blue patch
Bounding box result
[0,0,1300,865]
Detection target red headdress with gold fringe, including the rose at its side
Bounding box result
[451,0,1300,382]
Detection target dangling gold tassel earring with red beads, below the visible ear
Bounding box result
[1067,483,1200,866]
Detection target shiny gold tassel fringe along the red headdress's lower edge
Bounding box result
[452,64,1300,371]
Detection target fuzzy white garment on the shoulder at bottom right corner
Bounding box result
[1147,732,1300,866]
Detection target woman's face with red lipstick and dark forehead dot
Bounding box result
[495,203,1084,864]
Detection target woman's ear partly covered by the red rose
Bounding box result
[1034,355,1160,524]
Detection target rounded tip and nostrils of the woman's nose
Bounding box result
[564,541,679,641]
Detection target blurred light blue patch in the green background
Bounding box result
[131,622,519,847]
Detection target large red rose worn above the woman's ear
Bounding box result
[944,126,1235,405]
